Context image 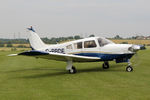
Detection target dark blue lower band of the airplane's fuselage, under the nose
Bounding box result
[75,53,134,61]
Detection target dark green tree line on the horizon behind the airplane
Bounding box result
[0,34,149,48]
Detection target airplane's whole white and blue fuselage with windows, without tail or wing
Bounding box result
[37,37,134,61]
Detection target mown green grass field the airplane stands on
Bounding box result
[0,48,150,100]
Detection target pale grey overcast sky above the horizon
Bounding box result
[0,0,150,38]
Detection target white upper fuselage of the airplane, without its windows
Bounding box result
[39,37,133,54]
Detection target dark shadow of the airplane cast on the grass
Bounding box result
[11,65,125,79]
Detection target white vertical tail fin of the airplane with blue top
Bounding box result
[27,26,47,50]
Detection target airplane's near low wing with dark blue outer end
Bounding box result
[10,50,100,62]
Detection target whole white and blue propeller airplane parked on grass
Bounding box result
[10,26,140,74]
